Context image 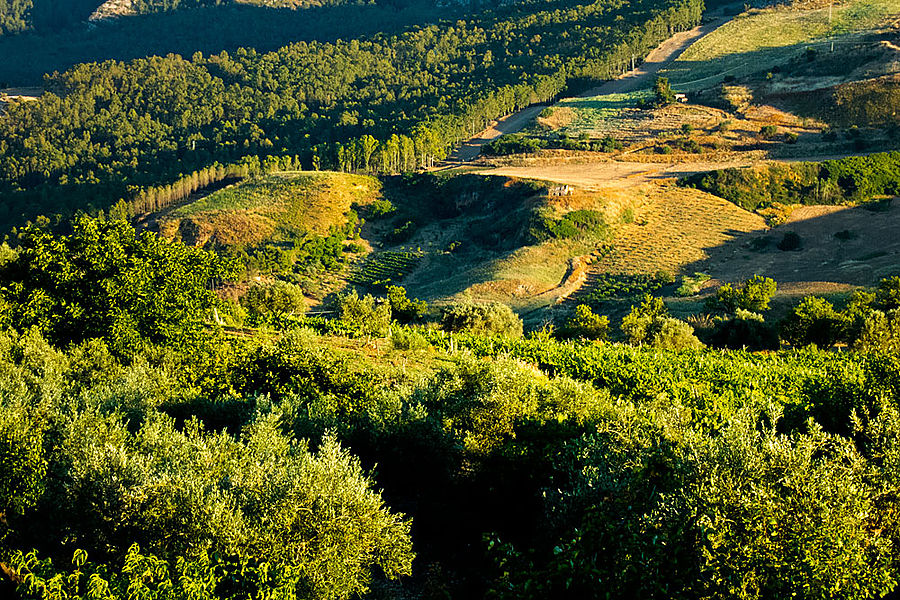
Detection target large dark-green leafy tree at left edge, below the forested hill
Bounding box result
[0,218,232,356]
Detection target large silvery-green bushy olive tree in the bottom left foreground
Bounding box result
[9,413,413,600]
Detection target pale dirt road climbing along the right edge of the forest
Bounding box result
[445,9,730,164]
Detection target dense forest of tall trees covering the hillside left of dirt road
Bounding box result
[0,0,702,229]
